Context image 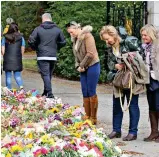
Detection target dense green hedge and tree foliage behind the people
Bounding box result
[1,1,143,82]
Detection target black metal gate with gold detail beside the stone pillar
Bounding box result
[106,1,148,38]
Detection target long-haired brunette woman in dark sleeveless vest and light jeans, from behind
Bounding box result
[2,23,25,89]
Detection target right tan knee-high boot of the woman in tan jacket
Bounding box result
[90,95,98,124]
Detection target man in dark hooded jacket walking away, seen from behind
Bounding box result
[28,13,66,98]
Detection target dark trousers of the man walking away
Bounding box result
[37,60,56,96]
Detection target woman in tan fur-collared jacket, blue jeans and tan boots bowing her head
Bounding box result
[66,21,100,124]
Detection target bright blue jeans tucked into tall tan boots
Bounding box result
[80,62,100,97]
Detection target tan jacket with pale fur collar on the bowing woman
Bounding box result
[73,26,99,69]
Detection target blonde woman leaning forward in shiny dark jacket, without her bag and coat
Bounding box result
[100,25,140,141]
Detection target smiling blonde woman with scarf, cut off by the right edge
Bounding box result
[140,24,159,142]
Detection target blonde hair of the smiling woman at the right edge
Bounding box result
[140,24,159,41]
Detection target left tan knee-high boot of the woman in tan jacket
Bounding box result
[83,97,91,120]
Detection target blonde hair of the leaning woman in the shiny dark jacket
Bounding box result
[100,25,121,42]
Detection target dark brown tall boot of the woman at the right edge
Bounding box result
[144,111,159,142]
